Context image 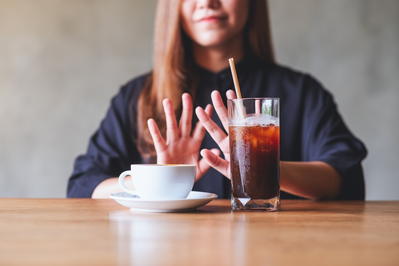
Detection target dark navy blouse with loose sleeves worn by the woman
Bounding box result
[67,58,367,200]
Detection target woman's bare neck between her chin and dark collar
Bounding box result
[193,35,244,73]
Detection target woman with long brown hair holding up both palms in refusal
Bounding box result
[68,0,366,199]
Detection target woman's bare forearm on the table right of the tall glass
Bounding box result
[280,162,342,200]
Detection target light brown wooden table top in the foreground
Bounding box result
[0,198,399,265]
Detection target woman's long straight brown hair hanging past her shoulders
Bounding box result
[133,0,274,162]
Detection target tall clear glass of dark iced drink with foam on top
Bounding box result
[227,98,280,211]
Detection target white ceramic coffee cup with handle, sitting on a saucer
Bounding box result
[119,164,197,200]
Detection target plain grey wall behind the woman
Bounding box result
[0,0,399,200]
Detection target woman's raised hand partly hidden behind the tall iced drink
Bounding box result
[195,90,236,179]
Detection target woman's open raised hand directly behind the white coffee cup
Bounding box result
[147,93,220,180]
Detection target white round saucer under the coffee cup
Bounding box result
[110,191,218,212]
